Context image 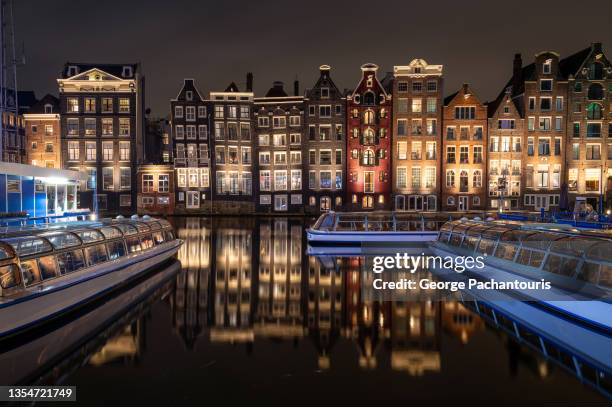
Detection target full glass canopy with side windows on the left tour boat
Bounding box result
[0,221,175,297]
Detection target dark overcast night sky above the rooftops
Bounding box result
[14,0,612,116]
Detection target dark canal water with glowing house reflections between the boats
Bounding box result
[0,218,609,406]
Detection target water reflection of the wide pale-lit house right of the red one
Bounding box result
[391,301,442,376]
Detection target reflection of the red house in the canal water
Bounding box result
[345,257,389,369]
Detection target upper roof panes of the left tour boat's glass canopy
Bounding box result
[0,219,171,261]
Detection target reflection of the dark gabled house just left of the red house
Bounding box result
[306,256,344,369]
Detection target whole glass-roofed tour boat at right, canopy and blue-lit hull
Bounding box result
[430,220,612,334]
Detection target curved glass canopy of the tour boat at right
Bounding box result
[438,220,612,290]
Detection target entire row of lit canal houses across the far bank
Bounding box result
[19,43,612,214]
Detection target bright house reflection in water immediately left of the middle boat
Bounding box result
[254,218,304,338]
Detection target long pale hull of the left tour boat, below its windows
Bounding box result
[0,240,182,339]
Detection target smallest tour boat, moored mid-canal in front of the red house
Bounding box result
[306,211,444,253]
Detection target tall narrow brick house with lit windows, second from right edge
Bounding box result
[523,52,567,211]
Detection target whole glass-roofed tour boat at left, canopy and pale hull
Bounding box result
[0,217,182,339]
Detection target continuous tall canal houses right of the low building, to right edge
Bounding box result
[152,43,612,217]
